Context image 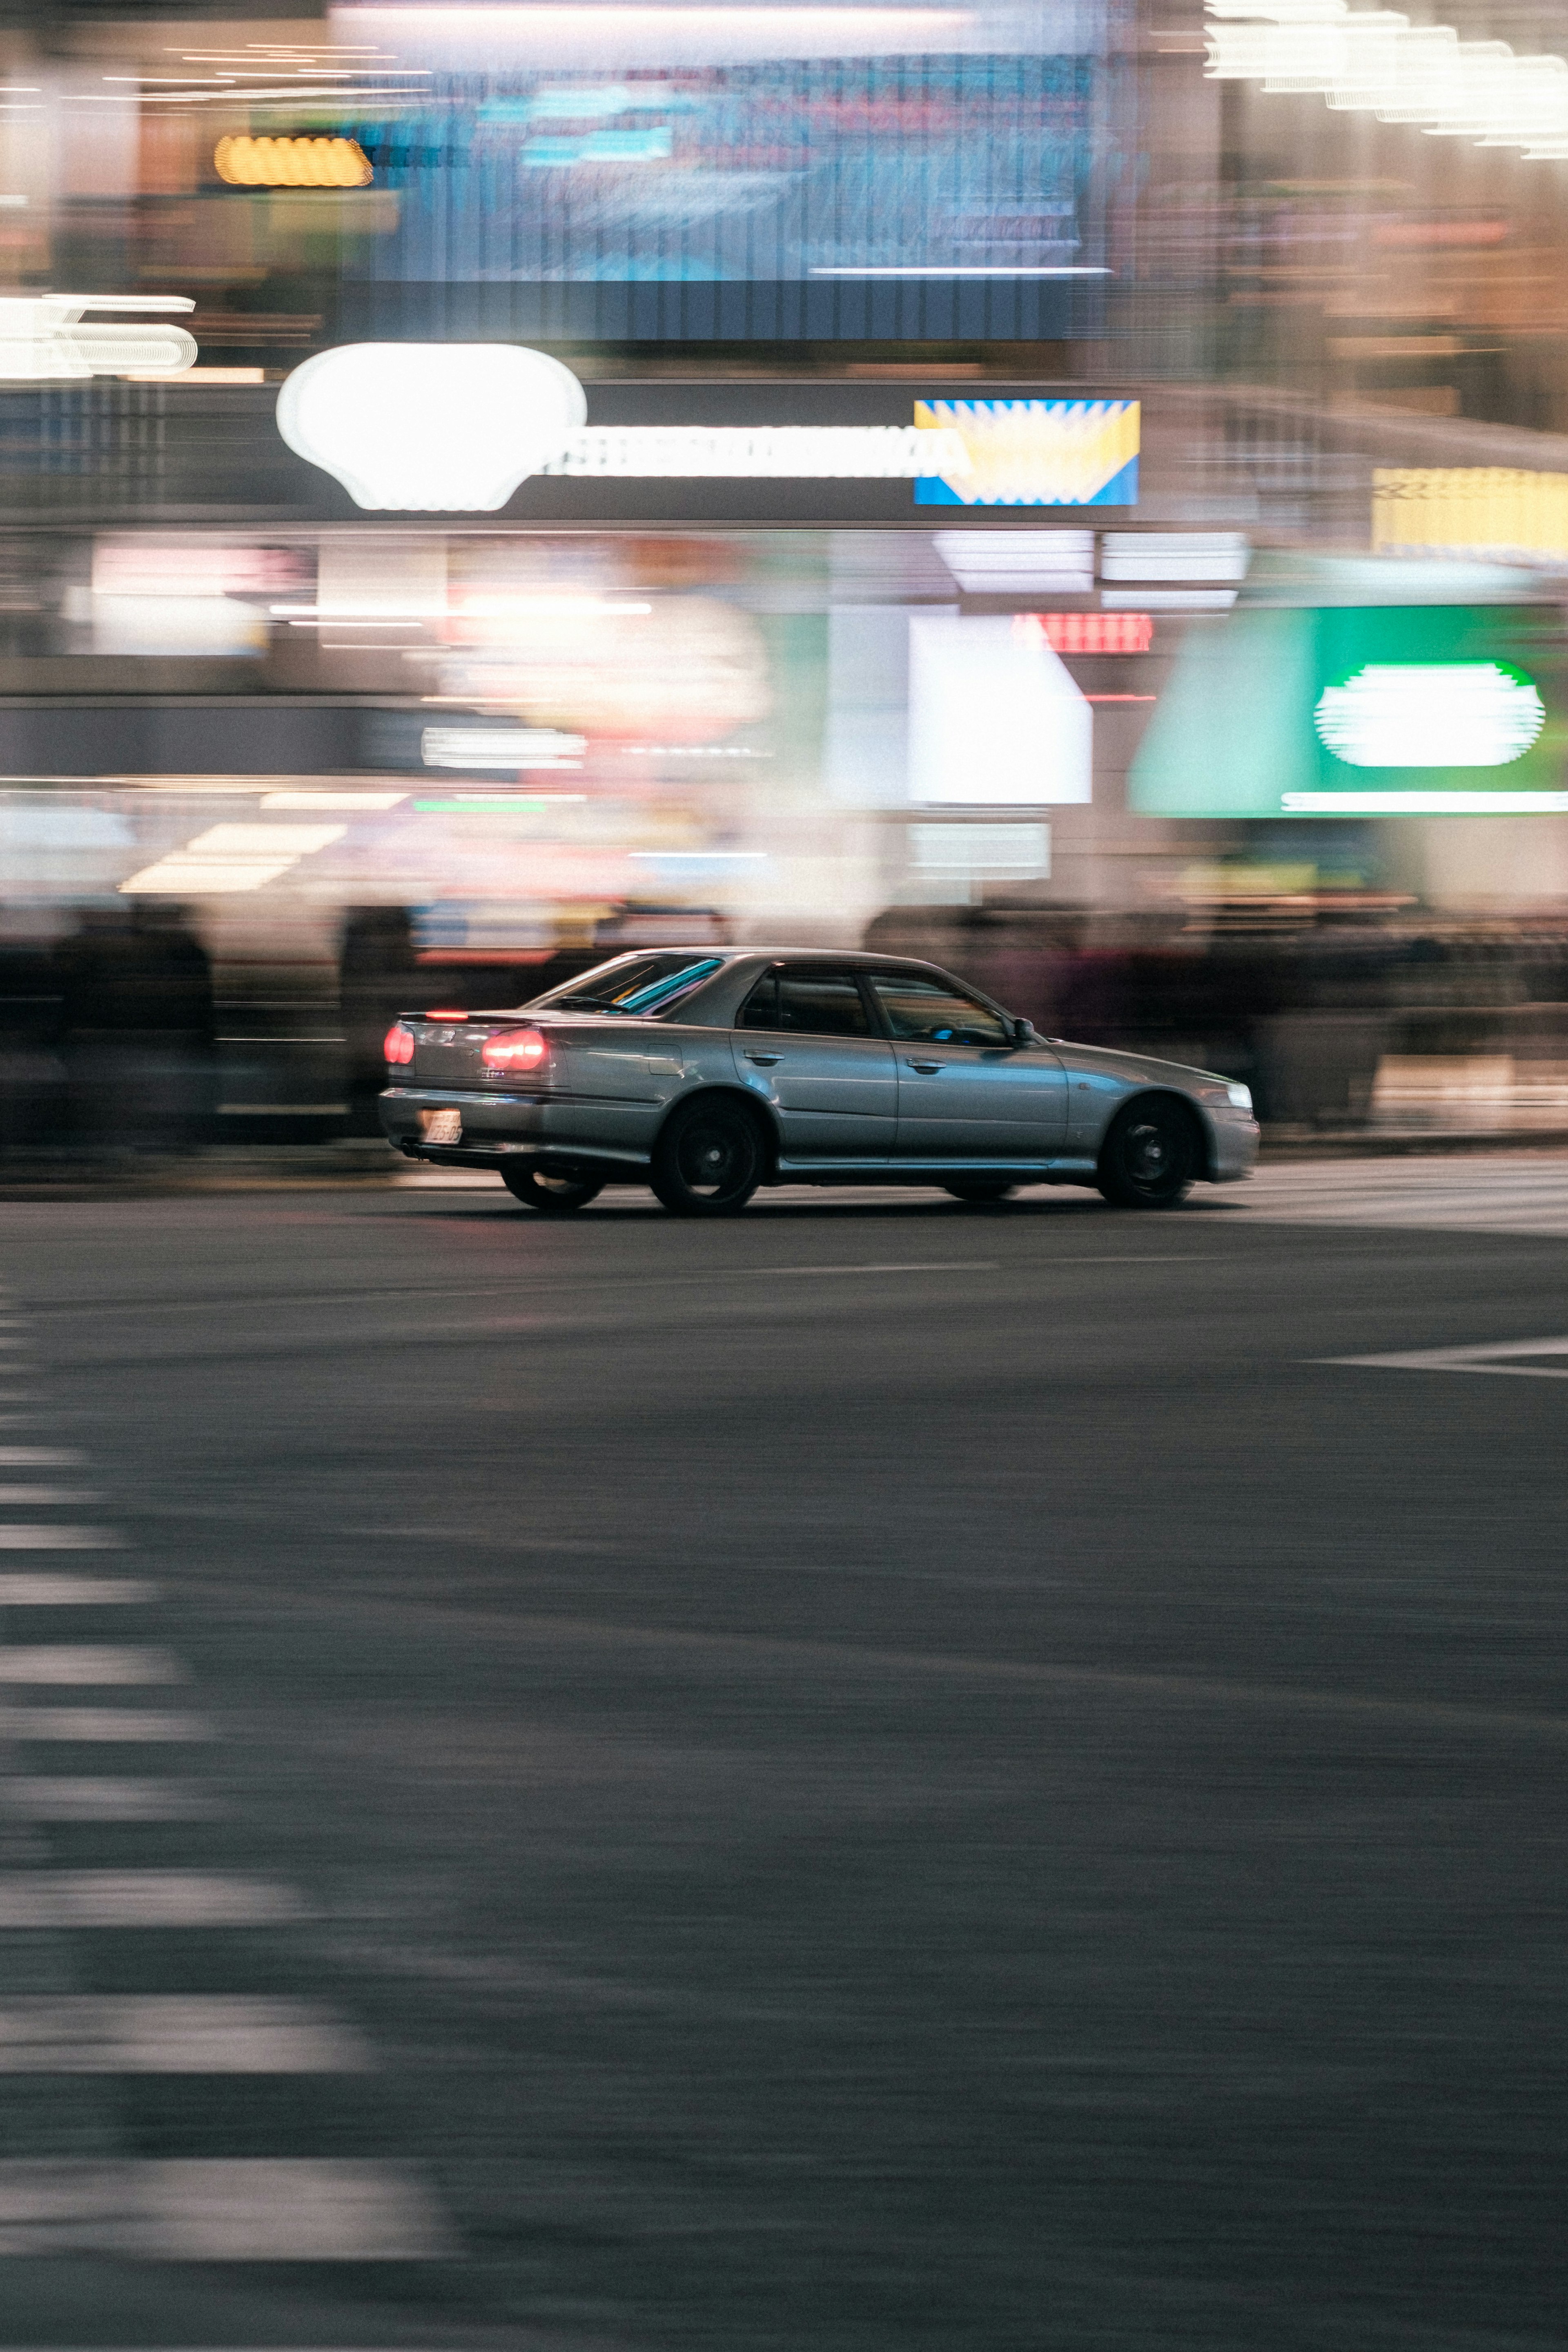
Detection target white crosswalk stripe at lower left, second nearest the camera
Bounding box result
[0,1994,374,2074]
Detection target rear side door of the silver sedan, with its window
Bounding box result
[733,964,898,1160]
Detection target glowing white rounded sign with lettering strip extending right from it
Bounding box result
[277,343,969,515]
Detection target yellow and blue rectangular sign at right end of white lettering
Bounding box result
[915,400,1140,506]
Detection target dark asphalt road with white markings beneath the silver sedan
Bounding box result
[0,1155,1568,2352]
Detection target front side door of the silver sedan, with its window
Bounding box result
[870,971,1067,1164]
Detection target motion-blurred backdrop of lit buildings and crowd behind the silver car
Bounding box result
[0,0,1568,1148]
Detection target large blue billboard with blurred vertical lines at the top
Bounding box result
[339,7,1117,341]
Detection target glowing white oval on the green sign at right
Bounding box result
[1312,661,1547,766]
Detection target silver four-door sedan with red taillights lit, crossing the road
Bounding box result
[381,948,1258,1216]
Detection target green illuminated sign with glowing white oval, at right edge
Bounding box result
[1128,604,1568,816]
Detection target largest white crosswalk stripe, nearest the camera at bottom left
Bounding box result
[0,2159,454,2263]
